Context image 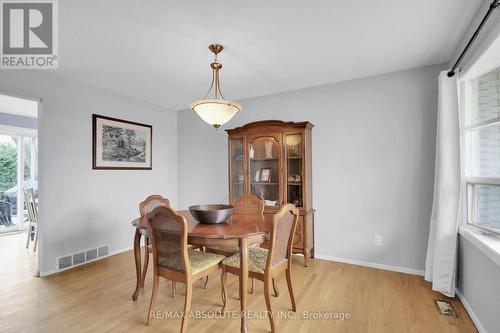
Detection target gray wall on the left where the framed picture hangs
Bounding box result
[0,70,177,274]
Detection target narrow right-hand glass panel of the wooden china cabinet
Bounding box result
[285,134,304,207]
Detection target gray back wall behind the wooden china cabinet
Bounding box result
[178,65,443,270]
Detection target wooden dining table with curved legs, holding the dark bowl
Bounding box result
[132,210,273,332]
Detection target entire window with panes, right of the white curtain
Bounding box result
[463,67,500,233]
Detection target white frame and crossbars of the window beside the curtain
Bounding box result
[460,67,500,235]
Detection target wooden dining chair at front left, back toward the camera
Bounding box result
[144,206,225,333]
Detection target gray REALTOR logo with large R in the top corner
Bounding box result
[0,0,58,69]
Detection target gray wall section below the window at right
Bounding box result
[457,236,500,333]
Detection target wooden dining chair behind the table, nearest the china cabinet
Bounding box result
[206,194,266,296]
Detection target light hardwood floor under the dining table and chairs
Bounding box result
[0,237,476,333]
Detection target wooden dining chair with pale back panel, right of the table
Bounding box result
[221,204,299,332]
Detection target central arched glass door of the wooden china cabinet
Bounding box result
[248,137,281,206]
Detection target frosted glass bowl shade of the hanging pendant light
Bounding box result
[191,99,241,128]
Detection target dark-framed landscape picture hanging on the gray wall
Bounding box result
[92,114,153,170]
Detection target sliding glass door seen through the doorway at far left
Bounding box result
[0,130,38,233]
